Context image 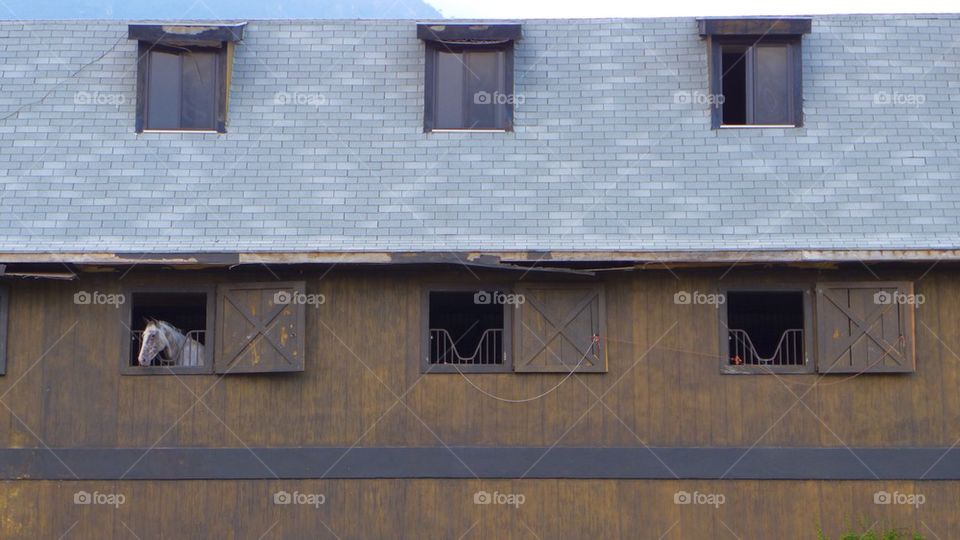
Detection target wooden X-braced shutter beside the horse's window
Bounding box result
[213,281,306,373]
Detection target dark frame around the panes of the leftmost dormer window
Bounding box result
[136,41,232,133]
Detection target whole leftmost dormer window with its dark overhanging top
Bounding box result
[128,24,244,133]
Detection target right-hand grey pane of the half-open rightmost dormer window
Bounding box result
[753,45,793,124]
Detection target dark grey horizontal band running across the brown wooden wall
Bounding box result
[0,447,960,480]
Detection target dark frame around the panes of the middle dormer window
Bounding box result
[423,41,514,133]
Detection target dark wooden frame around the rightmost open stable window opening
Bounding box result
[718,284,817,375]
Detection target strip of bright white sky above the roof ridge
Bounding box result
[430,0,960,19]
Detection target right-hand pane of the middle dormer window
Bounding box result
[464,51,509,129]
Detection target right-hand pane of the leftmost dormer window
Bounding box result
[181,51,217,129]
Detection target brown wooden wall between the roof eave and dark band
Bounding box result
[0,265,960,447]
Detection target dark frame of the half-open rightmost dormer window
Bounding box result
[707,35,803,129]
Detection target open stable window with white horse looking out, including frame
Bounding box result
[122,288,214,374]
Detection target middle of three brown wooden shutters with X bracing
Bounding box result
[513,284,607,373]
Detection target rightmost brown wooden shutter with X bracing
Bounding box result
[817,282,916,373]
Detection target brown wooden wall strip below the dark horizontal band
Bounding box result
[0,480,960,540]
